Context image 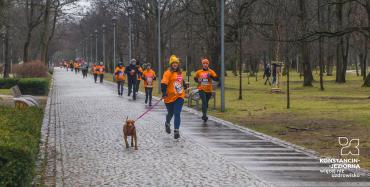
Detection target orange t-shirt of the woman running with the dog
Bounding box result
[161,70,185,103]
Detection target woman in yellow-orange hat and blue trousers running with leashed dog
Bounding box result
[161,55,187,139]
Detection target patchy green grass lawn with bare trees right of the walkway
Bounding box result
[106,72,370,169]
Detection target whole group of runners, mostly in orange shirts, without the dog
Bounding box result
[65,55,218,139]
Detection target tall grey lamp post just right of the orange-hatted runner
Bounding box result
[221,0,225,112]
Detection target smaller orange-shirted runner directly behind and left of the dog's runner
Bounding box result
[142,63,156,106]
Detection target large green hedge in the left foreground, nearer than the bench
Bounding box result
[0,106,43,186]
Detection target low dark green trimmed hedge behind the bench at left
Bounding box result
[0,78,50,95]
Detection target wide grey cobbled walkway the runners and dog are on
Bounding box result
[41,69,370,186]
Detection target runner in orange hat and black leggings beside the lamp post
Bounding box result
[194,58,218,122]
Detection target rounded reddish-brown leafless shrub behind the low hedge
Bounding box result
[13,61,48,78]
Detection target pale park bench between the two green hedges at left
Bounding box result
[10,85,40,109]
